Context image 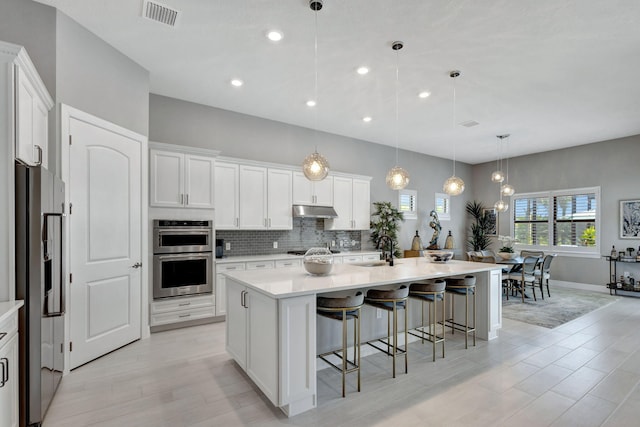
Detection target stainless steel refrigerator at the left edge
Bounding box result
[16,163,65,427]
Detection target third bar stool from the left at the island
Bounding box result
[409,279,446,362]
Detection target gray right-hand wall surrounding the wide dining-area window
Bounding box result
[473,135,640,285]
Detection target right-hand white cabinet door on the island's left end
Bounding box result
[246,291,279,406]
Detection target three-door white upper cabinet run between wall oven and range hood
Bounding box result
[215,162,293,230]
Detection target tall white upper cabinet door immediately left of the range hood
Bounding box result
[267,169,293,230]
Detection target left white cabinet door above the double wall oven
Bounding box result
[149,150,184,207]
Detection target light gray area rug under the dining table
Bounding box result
[502,287,616,329]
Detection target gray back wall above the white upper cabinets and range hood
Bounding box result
[149,94,473,249]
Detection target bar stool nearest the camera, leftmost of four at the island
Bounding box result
[316,291,364,397]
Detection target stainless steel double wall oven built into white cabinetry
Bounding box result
[153,219,215,299]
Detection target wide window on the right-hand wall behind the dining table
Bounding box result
[511,187,600,254]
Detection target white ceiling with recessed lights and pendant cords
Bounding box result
[39,0,640,164]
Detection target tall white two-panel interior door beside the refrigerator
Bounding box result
[67,117,142,369]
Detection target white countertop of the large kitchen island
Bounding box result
[223,257,502,298]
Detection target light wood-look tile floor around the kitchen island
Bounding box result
[43,290,640,427]
